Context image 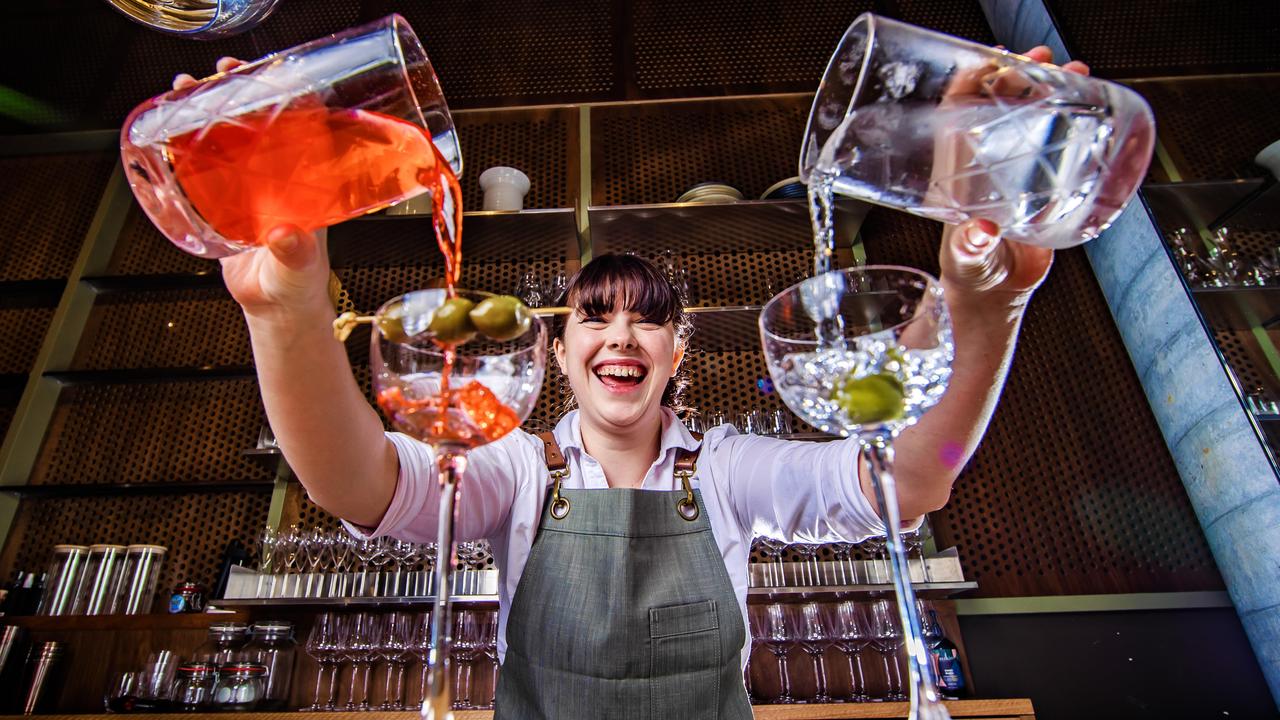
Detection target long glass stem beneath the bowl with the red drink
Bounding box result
[422,447,467,720]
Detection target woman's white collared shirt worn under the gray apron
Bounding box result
[347,407,884,662]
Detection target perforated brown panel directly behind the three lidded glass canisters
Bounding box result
[0,486,271,602]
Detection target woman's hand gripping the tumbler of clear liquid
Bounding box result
[941,45,1089,313]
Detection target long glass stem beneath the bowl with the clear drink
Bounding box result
[860,434,951,720]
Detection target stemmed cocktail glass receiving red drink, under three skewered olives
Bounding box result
[370,290,548,719]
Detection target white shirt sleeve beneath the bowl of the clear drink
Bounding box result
[708,430,884,543]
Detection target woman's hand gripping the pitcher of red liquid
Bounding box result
[173,58,333,319]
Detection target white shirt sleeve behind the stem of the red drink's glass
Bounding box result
[343,430,529,542]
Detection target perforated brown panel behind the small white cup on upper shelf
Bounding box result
[453,108,579,210]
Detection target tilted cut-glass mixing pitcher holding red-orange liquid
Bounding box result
[120,15,462,258]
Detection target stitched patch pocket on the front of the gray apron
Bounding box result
[649,600,723,720]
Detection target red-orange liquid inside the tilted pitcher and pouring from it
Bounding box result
[166,105,462,285]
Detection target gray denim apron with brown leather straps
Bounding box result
[494,433,751,720]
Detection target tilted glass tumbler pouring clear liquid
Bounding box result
[800,13,1156,247]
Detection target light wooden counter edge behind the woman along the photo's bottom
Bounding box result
[0,698,1036,720]
